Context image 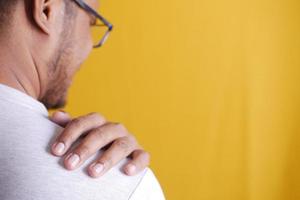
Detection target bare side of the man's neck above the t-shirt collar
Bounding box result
[0,37,41,99]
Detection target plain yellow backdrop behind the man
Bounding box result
[66,0,300,200]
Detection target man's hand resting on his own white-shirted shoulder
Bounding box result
[50,111,150,177]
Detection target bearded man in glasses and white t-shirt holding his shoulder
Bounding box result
[0,0,164,200]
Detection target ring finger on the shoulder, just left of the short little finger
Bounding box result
[88,136,137,178]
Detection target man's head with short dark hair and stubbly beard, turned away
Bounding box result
[0,0,97,108]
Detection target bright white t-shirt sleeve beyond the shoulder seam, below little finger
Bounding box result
[129,168,165,200]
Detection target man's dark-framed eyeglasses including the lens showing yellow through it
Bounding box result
[74,0,113,48]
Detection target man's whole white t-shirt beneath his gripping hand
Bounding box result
[0,84,165,200]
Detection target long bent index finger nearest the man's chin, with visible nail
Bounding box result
[51,113,106,156]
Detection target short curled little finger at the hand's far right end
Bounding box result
[123,149,150,176]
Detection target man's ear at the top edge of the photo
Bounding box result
[32,0,59,34]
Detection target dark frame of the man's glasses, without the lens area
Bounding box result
[74,0,113,48]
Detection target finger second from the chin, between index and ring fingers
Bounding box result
[64,123,127,170]
